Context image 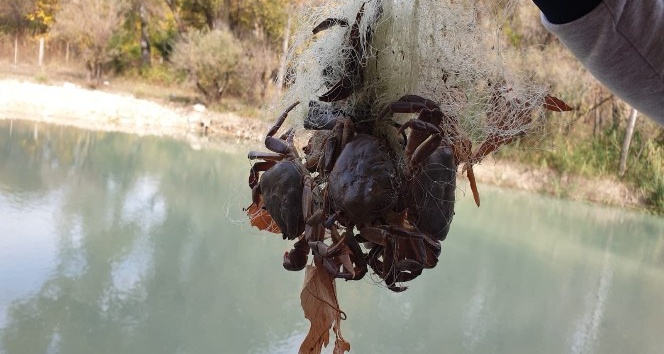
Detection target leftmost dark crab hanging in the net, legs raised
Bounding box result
[248,102,311,270]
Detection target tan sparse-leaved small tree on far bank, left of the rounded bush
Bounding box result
[53,0,128,87]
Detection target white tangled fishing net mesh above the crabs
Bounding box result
[271,0,547,162]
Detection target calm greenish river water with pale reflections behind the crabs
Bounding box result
[0,122,664,354]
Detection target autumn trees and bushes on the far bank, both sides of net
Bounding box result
[0,0,664,214]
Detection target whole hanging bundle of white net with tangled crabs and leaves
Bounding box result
[247,0,570,352]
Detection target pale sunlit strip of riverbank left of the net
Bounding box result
[0,79,264,140]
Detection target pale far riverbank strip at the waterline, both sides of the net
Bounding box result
[0,79,646,213]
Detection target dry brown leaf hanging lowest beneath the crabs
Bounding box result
[299,265,350,354]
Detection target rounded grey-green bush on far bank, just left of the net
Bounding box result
[170,30,242,103]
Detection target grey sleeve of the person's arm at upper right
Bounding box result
[541,0,664,125]
